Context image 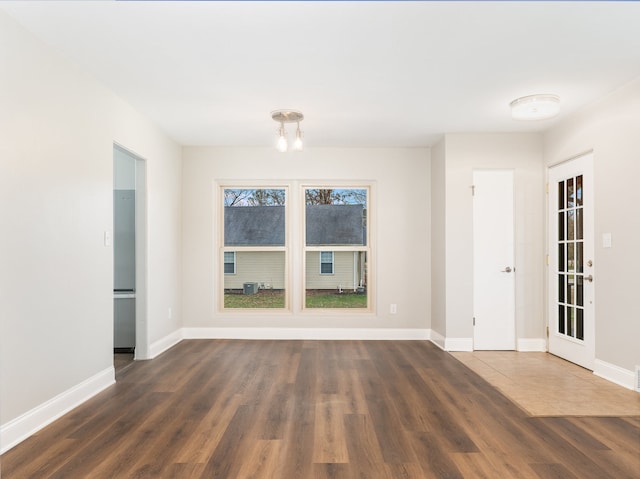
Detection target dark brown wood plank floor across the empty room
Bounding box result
[1,340,640,479]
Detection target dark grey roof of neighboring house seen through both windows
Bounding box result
[224,205,366,246]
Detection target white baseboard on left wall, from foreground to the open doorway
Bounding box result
[0,366,116,454]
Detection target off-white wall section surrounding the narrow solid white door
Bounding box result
[433,133,545,348]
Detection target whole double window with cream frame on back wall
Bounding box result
[216,181,372,312]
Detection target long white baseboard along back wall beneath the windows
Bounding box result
[182,328,430,340]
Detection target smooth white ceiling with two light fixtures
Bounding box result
[0,1,640,147]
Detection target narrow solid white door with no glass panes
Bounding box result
[473,170,516,350]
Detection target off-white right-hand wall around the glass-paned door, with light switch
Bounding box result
[544,78,640,371]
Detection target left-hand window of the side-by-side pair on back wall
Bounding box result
[220,186,288,309]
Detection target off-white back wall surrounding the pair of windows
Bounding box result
[182,147,431,329]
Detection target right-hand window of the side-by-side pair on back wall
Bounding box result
[304,185,371,310]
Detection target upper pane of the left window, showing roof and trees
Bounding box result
[224,189,286,246]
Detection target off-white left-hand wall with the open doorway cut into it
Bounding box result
[0,12,181,447]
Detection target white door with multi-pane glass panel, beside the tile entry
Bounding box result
[549,154,595,370]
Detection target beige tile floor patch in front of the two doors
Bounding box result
[451,351,640,416]
